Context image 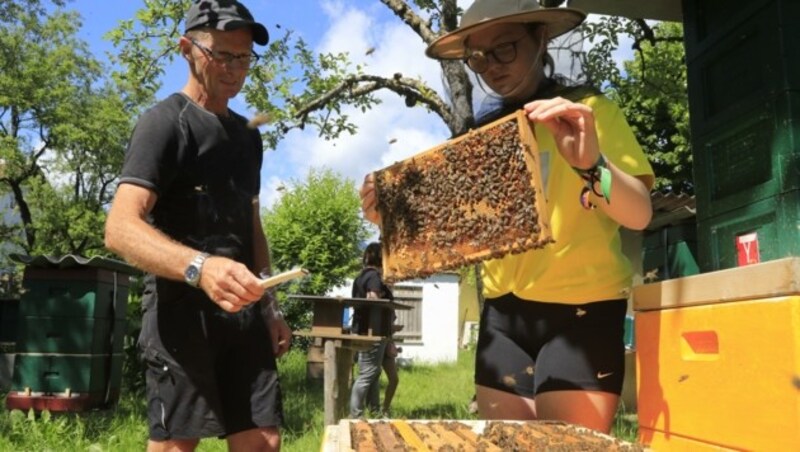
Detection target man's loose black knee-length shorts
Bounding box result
[139,294,283,441]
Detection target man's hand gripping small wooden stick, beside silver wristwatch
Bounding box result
[200,256,264,312]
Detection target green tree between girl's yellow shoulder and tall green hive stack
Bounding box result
[583,17,693,193]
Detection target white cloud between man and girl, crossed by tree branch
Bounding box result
[261,0,450,205]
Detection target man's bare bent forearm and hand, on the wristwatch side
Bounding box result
[105,183,263,312]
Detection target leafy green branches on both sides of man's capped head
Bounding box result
[108,0,378,149]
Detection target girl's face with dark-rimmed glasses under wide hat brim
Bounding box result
[467,24,544,101]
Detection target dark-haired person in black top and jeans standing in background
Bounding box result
[350,242,394,419]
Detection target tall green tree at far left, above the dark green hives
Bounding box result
[0,0,138,262]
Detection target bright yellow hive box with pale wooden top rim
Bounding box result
[633,258,800,451]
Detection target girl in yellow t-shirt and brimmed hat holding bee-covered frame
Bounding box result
[361,0,654,432]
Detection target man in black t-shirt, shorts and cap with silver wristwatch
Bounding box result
[105,0,291,451]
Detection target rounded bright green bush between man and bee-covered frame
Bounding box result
[263,169,368,330]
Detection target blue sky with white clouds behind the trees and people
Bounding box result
[68,0,632,213]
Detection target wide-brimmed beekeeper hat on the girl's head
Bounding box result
[425,0,586,60]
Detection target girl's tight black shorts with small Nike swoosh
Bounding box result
[475,294,627,397]
